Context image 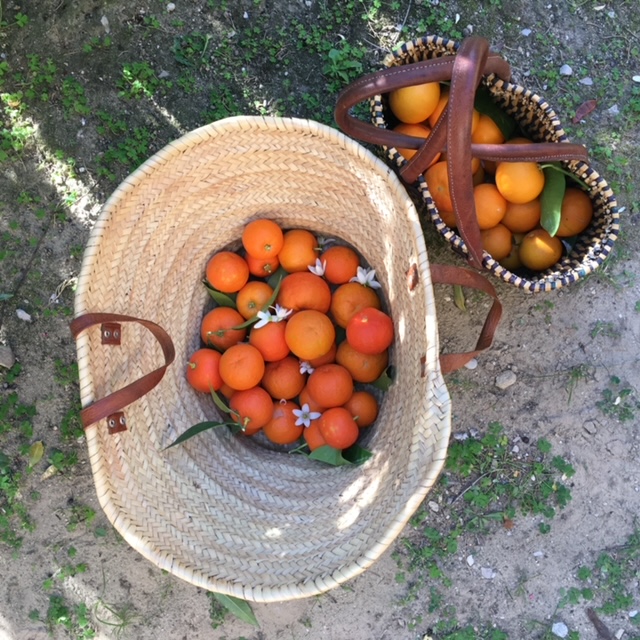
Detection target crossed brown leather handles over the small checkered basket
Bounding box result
[335,36,588,269]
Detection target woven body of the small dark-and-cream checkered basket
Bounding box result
[370,36,620,293]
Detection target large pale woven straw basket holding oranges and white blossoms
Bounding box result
[75,117,450,602]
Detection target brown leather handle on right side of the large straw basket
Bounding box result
[430,264,502,373]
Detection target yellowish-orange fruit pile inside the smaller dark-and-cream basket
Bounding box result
[388,82,593,271]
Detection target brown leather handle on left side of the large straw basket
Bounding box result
[70,313,176,430]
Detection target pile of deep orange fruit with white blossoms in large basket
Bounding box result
[186,219,394,451]
